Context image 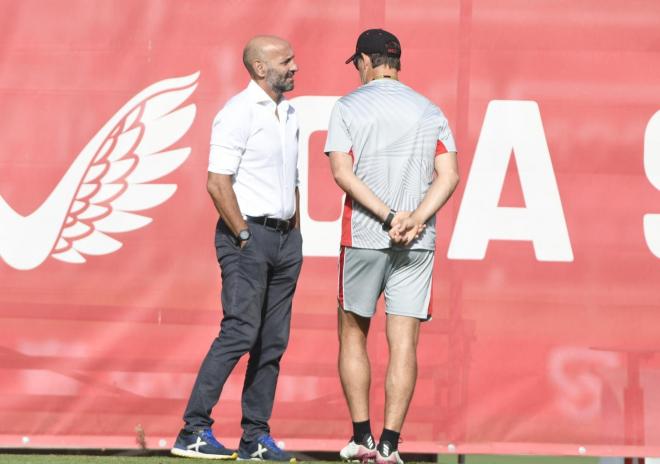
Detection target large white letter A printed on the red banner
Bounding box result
[448,100,573,261]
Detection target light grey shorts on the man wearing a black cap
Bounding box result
[338,247,434,320]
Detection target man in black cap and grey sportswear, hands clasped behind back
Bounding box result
[325,29,458,464]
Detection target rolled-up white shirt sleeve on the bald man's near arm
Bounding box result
[209,105,250,175]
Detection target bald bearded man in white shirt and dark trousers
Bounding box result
[171,36,302,462]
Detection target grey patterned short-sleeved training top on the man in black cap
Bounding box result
[325,78,456,250]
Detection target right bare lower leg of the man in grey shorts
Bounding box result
[384,314,420,432]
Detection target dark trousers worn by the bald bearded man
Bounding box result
[183,221,302,442]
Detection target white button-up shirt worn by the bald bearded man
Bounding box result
[209,80,298,219]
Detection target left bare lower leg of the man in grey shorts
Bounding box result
[338,307,371,422]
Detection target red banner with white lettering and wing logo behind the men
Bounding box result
[0,0,660,455]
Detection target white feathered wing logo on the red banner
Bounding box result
[0,72,199,270]
